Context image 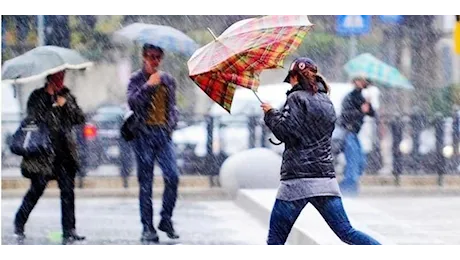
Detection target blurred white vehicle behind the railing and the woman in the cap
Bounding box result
[173,82,380,176]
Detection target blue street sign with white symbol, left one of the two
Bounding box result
[336,14,372,36]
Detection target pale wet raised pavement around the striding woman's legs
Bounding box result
[235,189,460,248]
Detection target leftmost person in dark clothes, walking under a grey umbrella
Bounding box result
[14,71,85,245]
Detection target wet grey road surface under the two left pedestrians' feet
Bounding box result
[1,198,267,247]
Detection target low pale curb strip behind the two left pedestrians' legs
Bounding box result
[2,188,231,201]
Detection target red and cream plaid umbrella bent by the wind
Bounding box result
[188,15,313,113]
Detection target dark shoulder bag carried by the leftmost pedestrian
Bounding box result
[10,118,54,157]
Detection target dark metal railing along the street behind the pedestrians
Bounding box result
[2,109,460,185]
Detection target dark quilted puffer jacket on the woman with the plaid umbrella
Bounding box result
[264,83,336,180]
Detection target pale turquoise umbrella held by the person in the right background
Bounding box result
[344,53,414,89]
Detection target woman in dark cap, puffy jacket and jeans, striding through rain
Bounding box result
[261,58,380,246]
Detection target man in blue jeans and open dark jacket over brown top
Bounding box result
[128,44,179,243]
